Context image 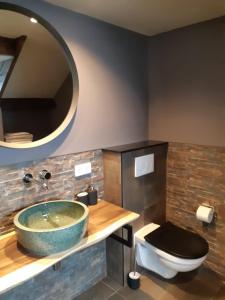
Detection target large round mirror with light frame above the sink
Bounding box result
[0,3,78,148]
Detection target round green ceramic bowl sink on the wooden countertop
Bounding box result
[14,200,88,256]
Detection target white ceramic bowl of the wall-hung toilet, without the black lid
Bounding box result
[135,223,207,279]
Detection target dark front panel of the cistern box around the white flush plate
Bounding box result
[122,144,167,225]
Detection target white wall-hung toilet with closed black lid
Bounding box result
[135,222,209,278]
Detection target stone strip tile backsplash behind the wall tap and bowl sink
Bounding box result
[0,150,103,235]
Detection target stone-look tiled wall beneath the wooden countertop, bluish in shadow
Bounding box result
[0,241,107,300]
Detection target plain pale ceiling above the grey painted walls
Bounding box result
[46,0,225,36]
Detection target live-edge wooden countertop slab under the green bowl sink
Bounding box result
[0,200,139,293]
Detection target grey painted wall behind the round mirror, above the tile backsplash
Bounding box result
[0,0,148,165]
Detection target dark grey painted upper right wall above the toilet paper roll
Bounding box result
[148,17,225,146]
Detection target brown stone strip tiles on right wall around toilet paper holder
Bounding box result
[167,143,225,279]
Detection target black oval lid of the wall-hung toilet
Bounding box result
[144,222,209,259]
